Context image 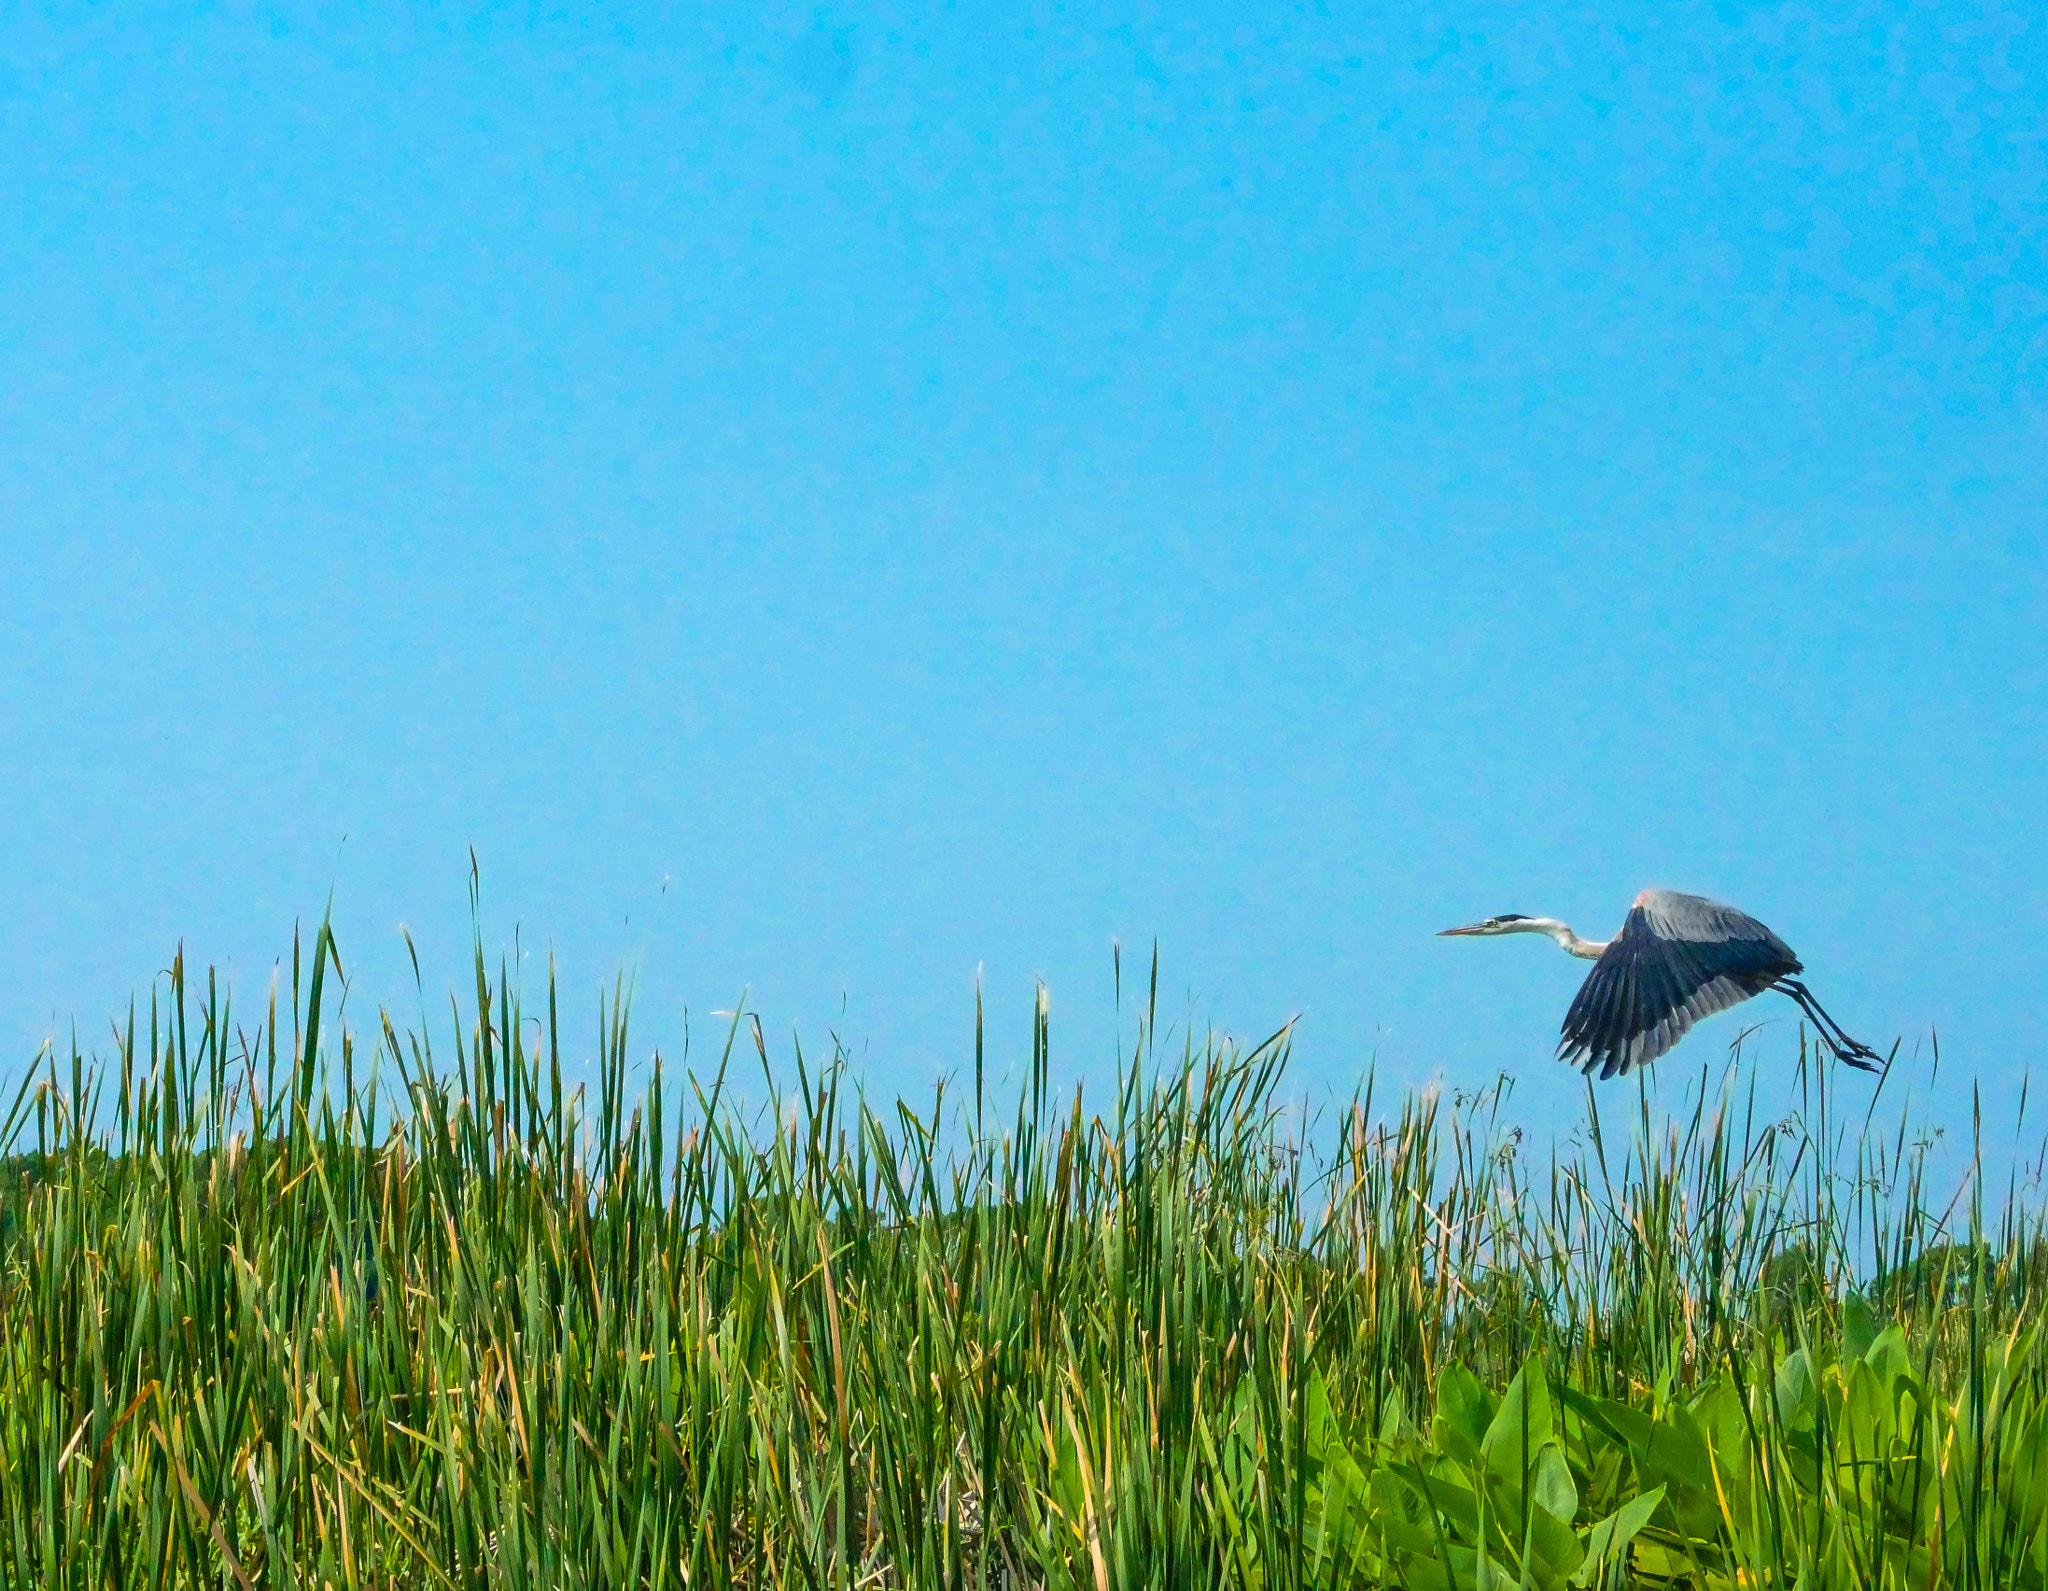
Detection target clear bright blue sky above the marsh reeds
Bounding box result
[0,4,2048,1154]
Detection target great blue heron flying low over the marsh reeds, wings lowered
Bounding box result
[1444,889,1884,1077]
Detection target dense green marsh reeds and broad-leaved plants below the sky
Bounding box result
[0,930,2048,1591]
